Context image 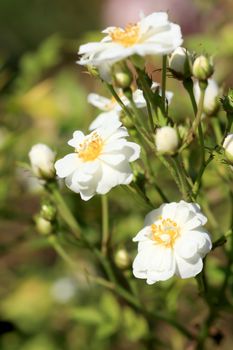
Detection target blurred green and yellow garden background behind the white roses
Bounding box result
[0,0,233,350]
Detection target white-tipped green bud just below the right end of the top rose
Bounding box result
[168,47,191,79]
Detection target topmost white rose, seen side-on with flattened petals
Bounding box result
[78,12,183,70]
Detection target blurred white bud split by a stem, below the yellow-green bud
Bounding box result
[193,79,220,115]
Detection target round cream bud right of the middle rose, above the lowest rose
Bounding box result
[155,126,179,154]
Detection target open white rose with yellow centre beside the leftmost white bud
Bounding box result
[55,121,140,201]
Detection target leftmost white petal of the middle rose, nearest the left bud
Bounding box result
[54,153,80,178]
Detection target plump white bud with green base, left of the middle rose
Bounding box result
[29,143,55,179]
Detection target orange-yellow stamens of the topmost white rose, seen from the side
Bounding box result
[109,24,140,47]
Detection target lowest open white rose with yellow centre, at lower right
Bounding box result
[133,201,212,284]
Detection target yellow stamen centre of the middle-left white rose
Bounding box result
[75,131,103,162]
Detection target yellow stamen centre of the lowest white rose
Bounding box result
[151,217,180,248]
